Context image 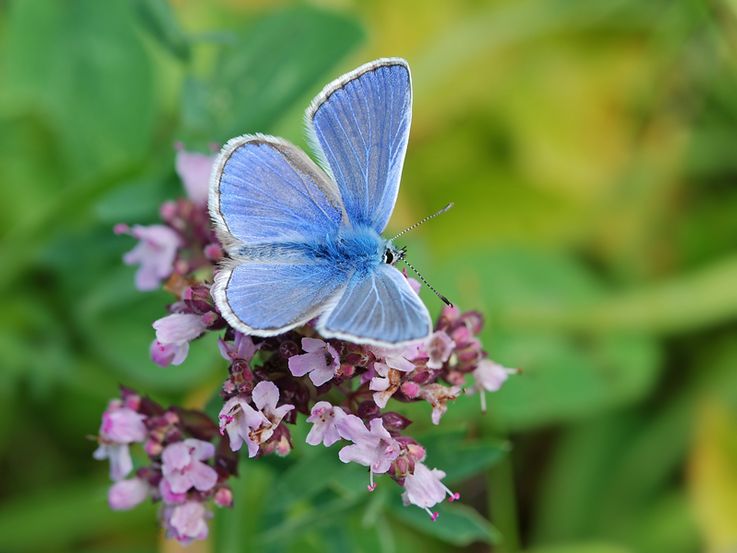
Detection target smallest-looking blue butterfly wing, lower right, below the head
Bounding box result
[318,264,432,346]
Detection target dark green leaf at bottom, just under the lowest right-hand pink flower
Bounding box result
[390,501,501,546]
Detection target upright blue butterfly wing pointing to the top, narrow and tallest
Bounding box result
[306,58,412,233]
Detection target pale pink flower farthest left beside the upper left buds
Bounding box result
[116,225,182,291]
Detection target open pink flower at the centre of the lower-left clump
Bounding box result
[161,438,218,494]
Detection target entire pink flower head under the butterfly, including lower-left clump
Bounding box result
[95,148,515,542]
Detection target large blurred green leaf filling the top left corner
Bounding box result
[2,0,156,178]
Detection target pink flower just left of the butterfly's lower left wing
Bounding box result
[151,313,211,367]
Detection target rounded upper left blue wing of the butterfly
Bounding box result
[209,134,344,254]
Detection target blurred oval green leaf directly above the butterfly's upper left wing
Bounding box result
[183,6,363,142]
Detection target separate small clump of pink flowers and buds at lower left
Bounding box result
[94,388,237,543]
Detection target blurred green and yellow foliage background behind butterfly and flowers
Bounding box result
[0,0,737,553]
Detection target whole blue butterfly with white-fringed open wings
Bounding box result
[209,58,442,346]
